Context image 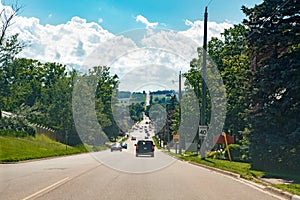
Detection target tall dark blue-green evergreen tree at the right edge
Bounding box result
[242,0,300,171]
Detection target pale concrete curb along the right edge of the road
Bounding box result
[163,151,300,200]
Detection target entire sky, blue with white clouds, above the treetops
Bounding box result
[0,0,262,79]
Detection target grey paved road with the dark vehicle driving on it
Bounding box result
[0,125,284,200]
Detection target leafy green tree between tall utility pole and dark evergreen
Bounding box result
[208,24,251,140]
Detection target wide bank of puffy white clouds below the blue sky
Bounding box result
[0,1,231,82]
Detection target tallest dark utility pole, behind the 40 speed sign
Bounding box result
[199,7,208,157]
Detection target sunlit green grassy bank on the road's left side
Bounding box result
[0,134,87,162]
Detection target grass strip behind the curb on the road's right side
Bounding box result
[168,152,300,195]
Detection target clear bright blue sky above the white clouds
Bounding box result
[2,0,262,34]
